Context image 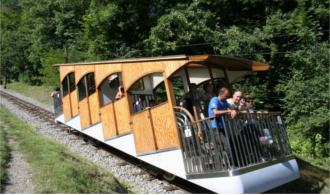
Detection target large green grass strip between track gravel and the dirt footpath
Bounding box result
[0,105,134,194]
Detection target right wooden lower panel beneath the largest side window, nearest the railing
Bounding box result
[150,103,179,149]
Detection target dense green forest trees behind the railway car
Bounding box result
[1,0,330,168]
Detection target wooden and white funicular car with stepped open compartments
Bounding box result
[53,55,299,193]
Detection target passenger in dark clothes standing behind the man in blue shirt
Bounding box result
[180,83,207,119]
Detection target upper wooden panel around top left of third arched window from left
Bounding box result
[95,64,122,86]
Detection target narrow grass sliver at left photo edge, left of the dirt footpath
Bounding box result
[0,117,10,192]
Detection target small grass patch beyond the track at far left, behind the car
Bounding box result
[7,82,55,105]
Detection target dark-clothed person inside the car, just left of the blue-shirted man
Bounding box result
[180,83,207,117]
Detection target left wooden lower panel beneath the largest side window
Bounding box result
[132,110,156,154]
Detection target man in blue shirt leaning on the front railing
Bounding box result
[208,88,237,156]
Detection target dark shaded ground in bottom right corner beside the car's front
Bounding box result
[282,156,329,194]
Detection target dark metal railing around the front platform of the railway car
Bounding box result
[174,107,292,175]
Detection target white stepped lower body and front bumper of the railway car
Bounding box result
[55,115,299,194]
